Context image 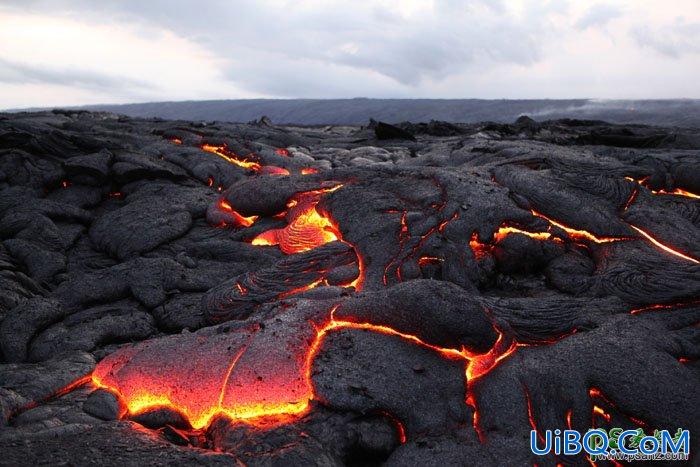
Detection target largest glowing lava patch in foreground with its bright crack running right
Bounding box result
[92,306,515,434]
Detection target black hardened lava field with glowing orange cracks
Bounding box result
[0,111,700,466]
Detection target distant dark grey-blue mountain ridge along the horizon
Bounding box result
[34,98,700,128]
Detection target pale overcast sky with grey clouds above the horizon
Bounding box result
[0,0,700,108]
